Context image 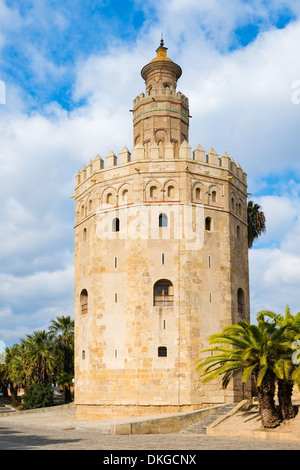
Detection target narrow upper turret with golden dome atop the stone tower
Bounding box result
[133,41,189,158]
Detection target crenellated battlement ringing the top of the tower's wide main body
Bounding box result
[76,141,247,187]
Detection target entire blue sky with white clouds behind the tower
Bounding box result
[0,0,300,345]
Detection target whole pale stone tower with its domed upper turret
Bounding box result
[75,42,249,419]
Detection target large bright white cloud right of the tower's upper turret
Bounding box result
[180,22,300,178]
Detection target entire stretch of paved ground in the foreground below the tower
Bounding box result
[0,400,300,451]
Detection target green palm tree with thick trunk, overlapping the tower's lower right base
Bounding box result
[197,320,281,428]
